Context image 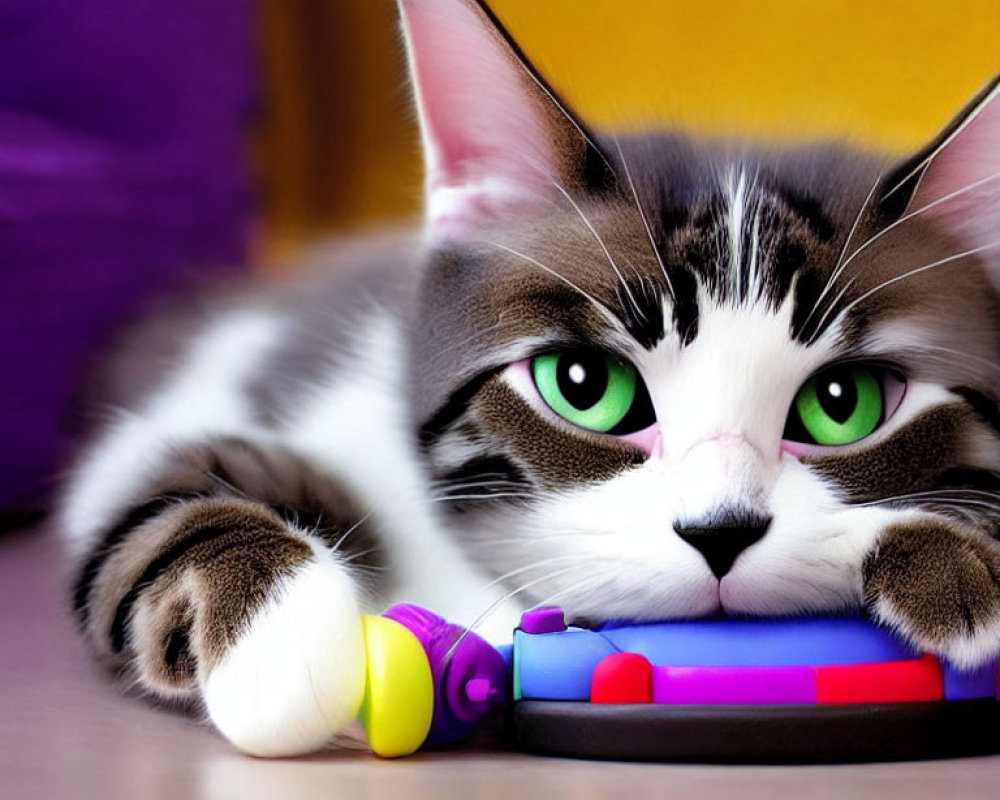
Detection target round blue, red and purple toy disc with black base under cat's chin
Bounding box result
[512,608,1000,762]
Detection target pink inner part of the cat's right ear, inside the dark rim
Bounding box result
[910,87,1000,262]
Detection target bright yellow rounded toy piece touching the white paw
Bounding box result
[361,615,434,758]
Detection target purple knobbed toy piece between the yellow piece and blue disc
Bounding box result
[382,603,507,746]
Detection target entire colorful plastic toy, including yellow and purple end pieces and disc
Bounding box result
[362,605,1000,761]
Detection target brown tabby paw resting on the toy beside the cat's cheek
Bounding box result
[864,519,1000,668]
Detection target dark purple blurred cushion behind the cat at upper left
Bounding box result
[0,0,255,509]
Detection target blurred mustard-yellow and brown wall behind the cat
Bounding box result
[258,0,1000,257]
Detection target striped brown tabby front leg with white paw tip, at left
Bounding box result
[76,440,371,756]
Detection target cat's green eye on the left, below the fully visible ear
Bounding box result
[531,350,654,435]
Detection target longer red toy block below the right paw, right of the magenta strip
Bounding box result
[816,655,944,704]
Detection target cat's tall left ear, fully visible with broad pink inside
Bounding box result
[398,0,593,239]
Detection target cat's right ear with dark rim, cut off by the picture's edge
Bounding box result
[883,76,1000,276]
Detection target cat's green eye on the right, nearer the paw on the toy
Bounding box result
[784,364,885,447]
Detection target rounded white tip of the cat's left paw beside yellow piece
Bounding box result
[203,554,365,756]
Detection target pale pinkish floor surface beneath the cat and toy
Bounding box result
[0,532,1000,800]
